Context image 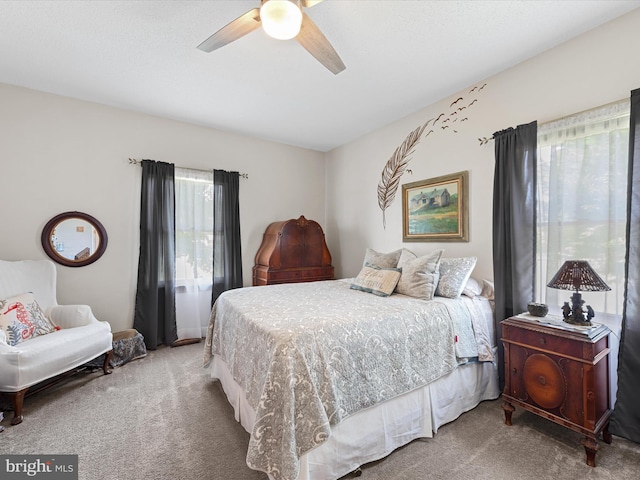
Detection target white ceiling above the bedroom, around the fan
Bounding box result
[0,0,640,151]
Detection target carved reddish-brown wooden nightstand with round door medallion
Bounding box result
[502,317,612,467]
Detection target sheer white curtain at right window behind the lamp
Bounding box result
[536,100,629,314]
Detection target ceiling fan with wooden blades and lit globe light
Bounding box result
[198,0,346,75]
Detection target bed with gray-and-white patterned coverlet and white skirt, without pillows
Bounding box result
[204,249,500,480]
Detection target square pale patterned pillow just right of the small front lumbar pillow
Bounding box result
[396,248,443,300]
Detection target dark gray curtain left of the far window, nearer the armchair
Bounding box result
[133,160,178,350]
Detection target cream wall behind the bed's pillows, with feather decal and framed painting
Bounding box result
[326,6,640,278]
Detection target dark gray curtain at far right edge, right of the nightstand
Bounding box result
[610,89,640,442]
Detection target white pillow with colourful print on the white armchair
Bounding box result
[0,293,56,346]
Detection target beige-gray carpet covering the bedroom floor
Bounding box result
[0,344,640,480]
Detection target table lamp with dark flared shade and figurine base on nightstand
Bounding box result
[547,260,611,326]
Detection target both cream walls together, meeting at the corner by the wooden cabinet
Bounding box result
[0,6,640,331]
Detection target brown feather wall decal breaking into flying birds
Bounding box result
[378,83,488,228]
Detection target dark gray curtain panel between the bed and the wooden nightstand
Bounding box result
[493,122,538,388]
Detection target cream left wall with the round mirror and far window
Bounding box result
[0,84,325,331]
